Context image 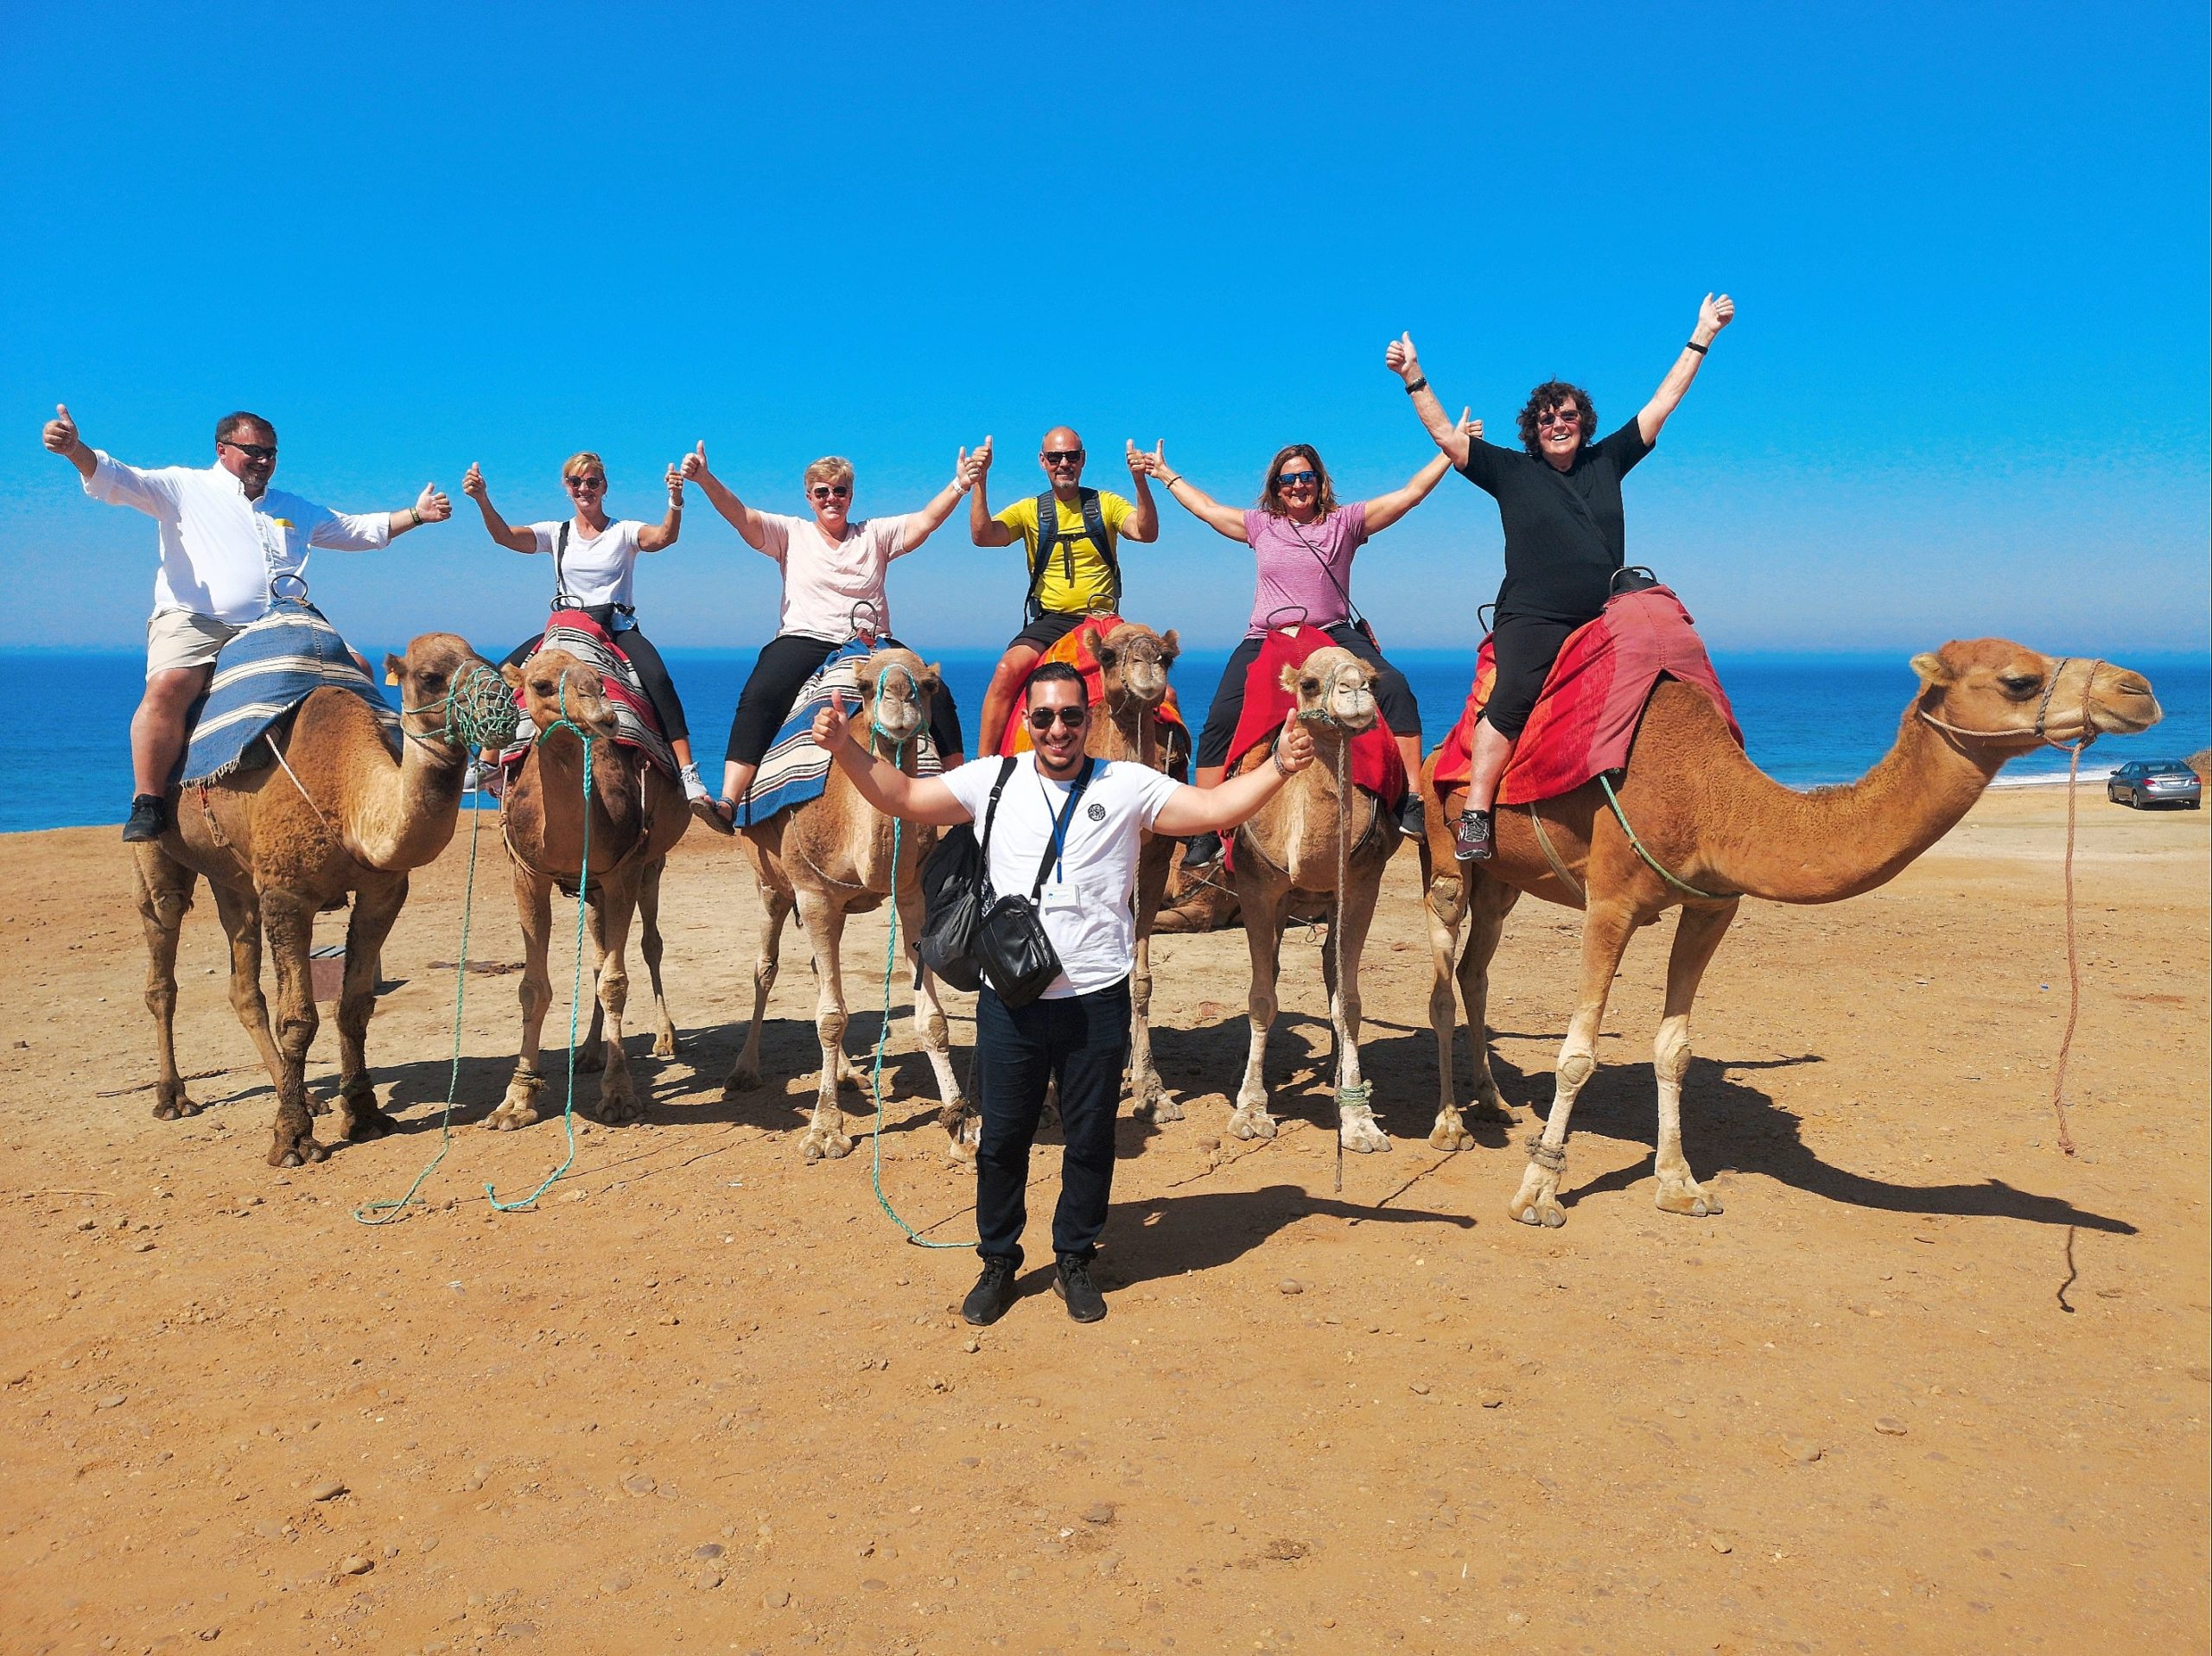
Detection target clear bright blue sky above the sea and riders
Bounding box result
[0,4,2212,652]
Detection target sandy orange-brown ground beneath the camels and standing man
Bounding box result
[0,790,2212,1652]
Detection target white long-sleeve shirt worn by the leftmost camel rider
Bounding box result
[84,449,391,625]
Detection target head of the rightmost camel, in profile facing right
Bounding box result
[1913,639,2165,756]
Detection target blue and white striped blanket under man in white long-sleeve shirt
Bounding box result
[183,600,400,783]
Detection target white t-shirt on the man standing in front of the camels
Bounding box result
[943,754,1181,999]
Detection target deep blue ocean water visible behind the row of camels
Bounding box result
[0,641,2212,834]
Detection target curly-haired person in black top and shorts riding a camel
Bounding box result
[1382,294,1737,862]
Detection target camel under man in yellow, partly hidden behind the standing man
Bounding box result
[1084,621,1190,1121]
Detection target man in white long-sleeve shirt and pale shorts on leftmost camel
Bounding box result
[44,404,454,841]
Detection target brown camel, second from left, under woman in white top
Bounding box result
[485,650,690,1132]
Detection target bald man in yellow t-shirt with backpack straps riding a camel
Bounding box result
[969,424,1159,754]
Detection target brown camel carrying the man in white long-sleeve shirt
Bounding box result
[135,632,491,1167]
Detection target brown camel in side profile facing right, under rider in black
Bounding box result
[1422,639,2159,1225]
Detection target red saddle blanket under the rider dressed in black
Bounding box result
[1435,586,1743,805]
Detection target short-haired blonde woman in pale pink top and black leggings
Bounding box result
[683,442,980,834]
